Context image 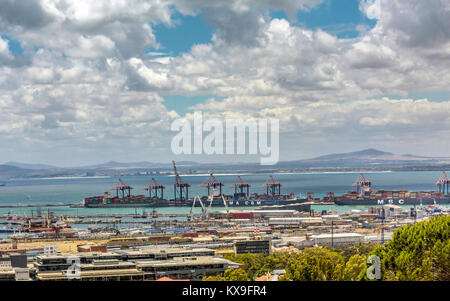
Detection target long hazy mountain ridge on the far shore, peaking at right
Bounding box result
[0,148,450,177]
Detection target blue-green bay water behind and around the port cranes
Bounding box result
[0,172,448,215]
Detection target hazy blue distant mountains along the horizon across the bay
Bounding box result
[0,148,450,179]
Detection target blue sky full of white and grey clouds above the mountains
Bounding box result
[0,0,450,166]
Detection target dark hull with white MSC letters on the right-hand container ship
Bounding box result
[334,197,450,206]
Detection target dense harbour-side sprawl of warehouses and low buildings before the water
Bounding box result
[0,196,450,281]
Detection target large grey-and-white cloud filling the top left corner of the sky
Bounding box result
[0,0,172,58]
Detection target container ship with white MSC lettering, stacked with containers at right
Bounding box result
[327,172,450,206]
